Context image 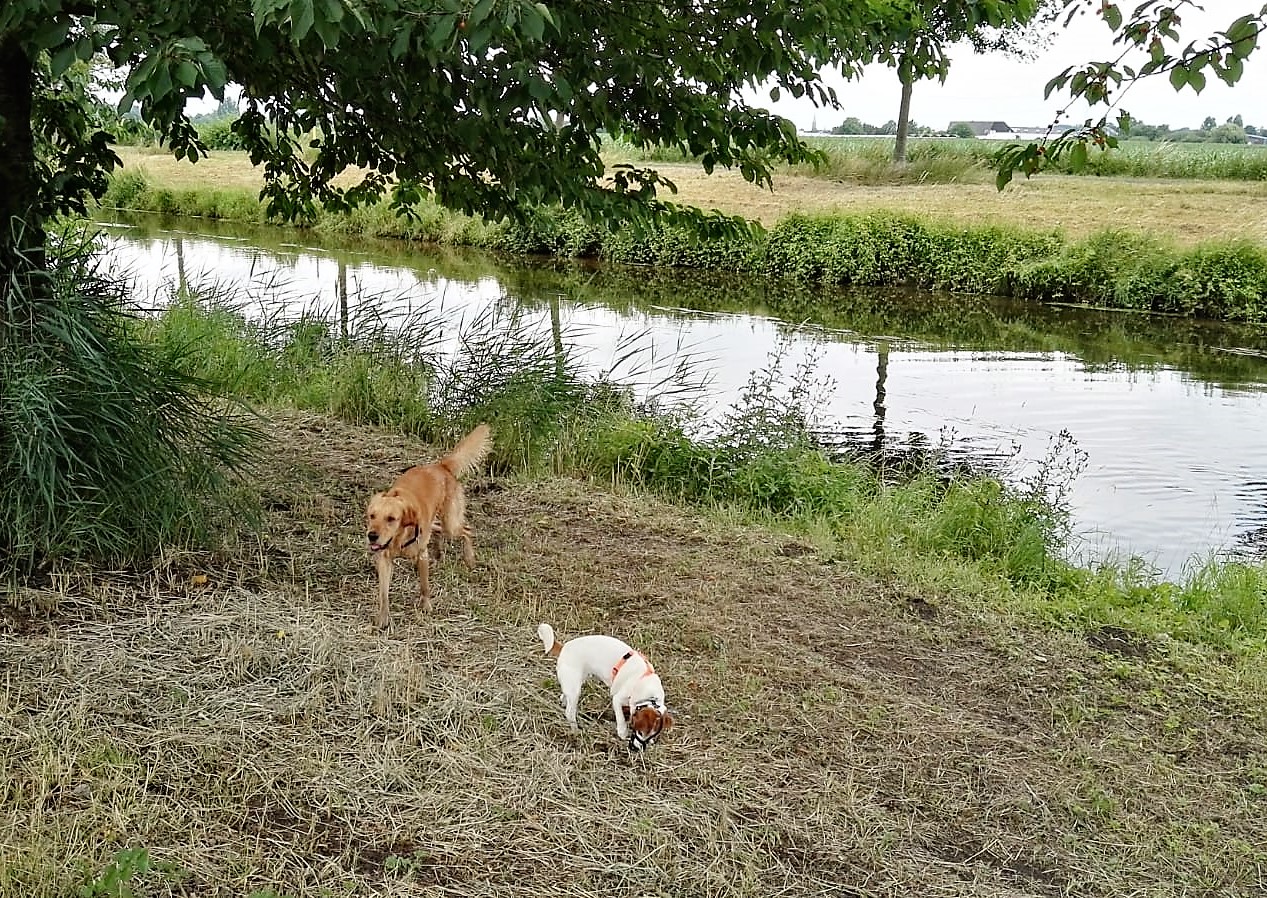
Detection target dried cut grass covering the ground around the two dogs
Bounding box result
[0,415,1267,898]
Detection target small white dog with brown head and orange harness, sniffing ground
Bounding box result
[537,623,673,751]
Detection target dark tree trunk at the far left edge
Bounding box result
[0,35,44,282]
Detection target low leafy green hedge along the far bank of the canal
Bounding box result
[101,170,1267,323]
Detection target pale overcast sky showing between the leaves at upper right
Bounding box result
[751,0,1267,130]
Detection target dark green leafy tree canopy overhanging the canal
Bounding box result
[0,0,1034,238]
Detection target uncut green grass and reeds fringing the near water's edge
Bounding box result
[143,287,1267,652]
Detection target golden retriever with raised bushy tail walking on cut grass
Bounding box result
[365,424,493,629]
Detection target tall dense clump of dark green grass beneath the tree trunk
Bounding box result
[0,231,257,581]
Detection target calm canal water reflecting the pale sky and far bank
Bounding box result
[96,217,1267,574]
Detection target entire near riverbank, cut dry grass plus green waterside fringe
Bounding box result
[9,269,1267,898]
